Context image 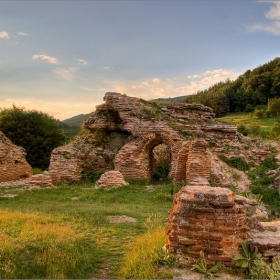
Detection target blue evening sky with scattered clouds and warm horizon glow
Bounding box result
[0,0,280,120]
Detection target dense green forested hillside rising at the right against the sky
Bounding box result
[184,57,280,116]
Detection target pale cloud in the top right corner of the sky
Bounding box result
[248,1,280,36]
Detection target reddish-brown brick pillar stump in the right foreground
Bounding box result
[167,179,247,266]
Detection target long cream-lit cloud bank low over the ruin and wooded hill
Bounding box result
[107,69,241,99]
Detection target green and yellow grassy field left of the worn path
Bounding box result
[0,182,180,278]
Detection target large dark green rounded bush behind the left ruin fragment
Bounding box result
[0,105,65,169]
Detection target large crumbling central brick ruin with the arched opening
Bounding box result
[49,92,269,187]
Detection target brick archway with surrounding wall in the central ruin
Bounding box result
[115,132,183,180]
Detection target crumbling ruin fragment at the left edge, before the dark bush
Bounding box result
[0,131,32,182]
